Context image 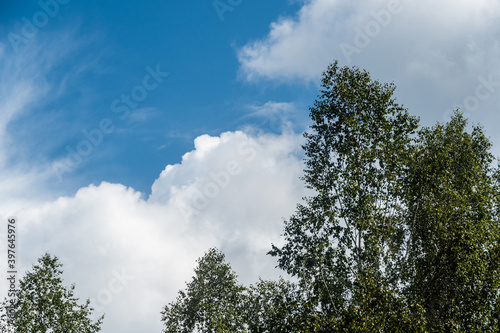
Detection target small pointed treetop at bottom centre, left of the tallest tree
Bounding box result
[162,248,245,333]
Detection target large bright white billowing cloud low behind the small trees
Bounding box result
[0,132,306,333]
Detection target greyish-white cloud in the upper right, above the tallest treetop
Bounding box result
[237,0,500,148]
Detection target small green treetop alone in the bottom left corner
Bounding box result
[1,254,104,333]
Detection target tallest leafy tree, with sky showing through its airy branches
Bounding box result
[271,63,417,330]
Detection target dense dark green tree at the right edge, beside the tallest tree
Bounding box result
[405,113,500,332]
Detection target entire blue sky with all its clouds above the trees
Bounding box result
[0,0,500,333]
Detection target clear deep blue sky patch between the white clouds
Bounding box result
[1,1,308,194]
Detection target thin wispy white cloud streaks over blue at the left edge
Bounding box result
[0,31,84,202]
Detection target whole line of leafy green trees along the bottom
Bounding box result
[0,62,500,333]
